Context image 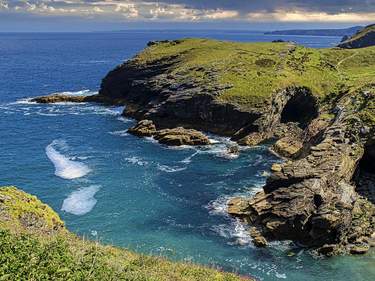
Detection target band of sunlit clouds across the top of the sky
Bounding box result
[0,0,375,22]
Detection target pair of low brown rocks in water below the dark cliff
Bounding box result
[128,120,210,146]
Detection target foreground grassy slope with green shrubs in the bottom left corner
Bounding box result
[0,187,248,281]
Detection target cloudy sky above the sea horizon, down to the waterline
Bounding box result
[0,0,375,32]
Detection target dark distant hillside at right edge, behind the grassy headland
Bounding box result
[338,24,375,49]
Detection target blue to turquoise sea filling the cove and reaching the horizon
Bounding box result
[0,31,375,281]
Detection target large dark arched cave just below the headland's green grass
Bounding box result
[280,89,319,129]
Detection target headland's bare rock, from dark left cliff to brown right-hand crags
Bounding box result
[33,42,375,255]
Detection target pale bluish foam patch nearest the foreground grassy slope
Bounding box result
[61,185,100,216]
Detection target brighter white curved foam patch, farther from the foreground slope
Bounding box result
[46,141,91,179]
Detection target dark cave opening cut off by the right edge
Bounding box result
[354,140,375,204]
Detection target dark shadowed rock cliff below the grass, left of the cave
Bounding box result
[100,42,262,136]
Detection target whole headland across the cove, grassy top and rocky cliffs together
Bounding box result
[35,27,375,255]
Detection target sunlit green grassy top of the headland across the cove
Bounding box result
[133,39,375,110]
